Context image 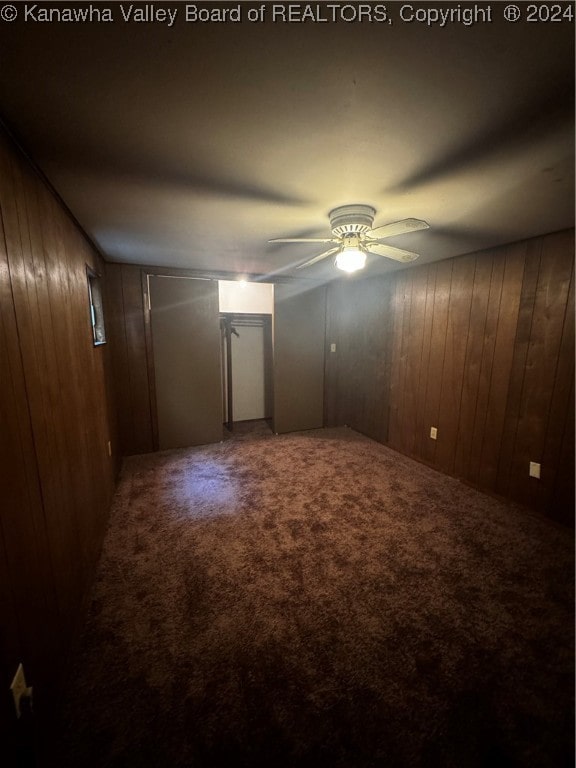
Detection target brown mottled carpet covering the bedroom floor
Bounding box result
[47,429,574,768]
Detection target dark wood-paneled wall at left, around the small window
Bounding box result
[0,133,116,764]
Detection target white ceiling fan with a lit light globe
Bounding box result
[268,204,429,272]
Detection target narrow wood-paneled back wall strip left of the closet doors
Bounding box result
[106,263,156,456]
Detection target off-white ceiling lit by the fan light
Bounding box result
[0,2,574,277]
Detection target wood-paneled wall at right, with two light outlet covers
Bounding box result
[326,230,574,522]
